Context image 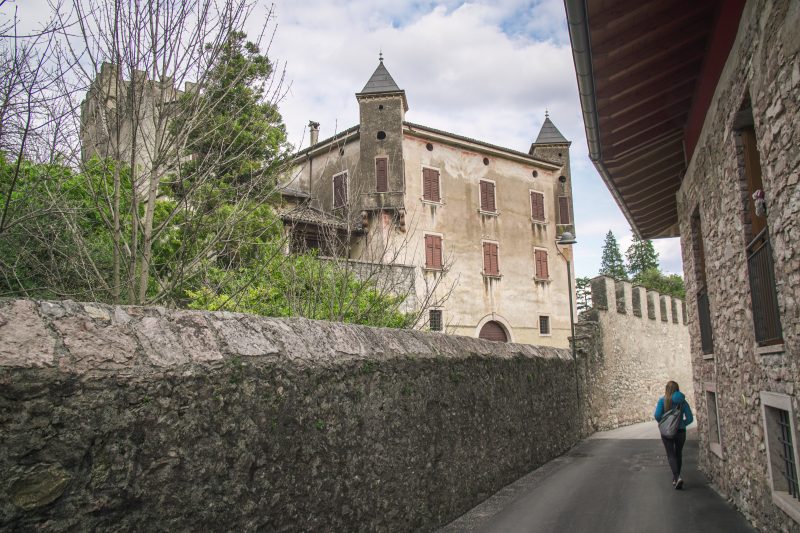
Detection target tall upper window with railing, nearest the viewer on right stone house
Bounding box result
[734,97,783,353]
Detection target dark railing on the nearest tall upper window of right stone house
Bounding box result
[747,228,783,346]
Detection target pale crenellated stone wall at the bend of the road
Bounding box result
[576,276,695,429]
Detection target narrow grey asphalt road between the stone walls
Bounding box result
[440,422,755,533]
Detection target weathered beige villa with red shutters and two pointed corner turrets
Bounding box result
[286,59,575,346]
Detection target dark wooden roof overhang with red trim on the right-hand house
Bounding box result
[564,0,745,238]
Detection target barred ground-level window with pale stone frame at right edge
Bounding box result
[761,391,800,522]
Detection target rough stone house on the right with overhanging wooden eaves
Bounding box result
[566,0,800,531]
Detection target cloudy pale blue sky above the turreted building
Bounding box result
[0,0,681,276]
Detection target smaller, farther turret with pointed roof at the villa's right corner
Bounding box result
[528,111,575,236]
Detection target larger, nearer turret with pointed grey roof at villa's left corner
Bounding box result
[353,54,408,212]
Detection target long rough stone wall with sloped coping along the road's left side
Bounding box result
[0,300,583,531]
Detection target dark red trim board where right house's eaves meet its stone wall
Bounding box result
[684,0,746,164]
